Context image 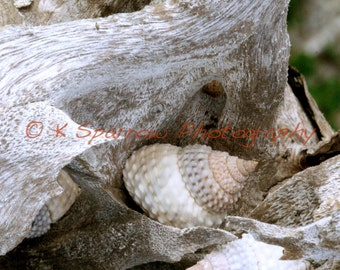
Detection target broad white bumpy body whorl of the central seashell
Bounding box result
[123,145,222,227]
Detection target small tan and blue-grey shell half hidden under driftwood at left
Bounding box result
[27,170,80,238]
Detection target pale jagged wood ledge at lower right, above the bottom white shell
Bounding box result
[223,212,340,265]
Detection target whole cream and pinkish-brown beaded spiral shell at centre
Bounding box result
[123,144,257,228]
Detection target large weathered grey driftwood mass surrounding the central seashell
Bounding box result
[0,0,340,269]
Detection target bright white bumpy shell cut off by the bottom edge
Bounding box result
[187,234,313,270]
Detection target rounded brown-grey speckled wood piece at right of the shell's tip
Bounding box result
[250,156,340,228]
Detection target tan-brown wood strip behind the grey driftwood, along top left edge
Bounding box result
[0,0,151,28]
